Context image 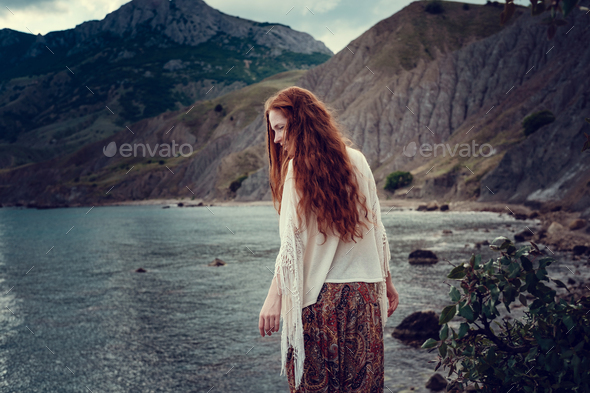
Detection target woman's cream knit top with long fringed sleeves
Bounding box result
[274,146,391,388]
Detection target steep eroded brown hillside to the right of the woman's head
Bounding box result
[300,2,590,217]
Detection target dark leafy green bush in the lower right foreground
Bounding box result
[422,237,590,393]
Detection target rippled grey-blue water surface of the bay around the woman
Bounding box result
[0,206,576,393]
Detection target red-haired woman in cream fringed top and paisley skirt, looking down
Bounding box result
[258,86,399,392]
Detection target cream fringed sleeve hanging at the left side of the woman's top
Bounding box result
[274,162,307,387]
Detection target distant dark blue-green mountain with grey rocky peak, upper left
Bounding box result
[0,0,333,168]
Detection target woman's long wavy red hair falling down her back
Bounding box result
[264,86,369,244]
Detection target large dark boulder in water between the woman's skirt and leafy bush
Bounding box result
[391,310,440,346]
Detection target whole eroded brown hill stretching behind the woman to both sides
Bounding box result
[0,1,590,220]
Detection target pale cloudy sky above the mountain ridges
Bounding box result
[0,0,530,53]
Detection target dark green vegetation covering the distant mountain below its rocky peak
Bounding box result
[0,30,330,168]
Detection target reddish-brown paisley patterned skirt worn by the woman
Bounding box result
[286,282,384,393]
